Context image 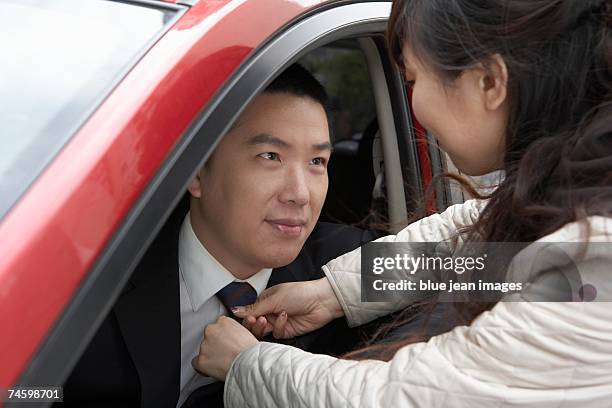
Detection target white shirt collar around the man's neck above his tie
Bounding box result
[179,213,272,312]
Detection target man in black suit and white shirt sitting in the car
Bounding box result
[64,65,373,407]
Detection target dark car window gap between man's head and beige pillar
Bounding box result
[299,39,386,229]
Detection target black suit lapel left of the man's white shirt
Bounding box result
[115,214,181,407]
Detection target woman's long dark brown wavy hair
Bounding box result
[349,0,612,360]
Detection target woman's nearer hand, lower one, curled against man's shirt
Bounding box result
[191,316,258,381]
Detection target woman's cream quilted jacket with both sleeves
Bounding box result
[225,201,612,408]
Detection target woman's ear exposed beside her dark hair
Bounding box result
[479,54,508,111]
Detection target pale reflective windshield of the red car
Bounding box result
[0,0,176,218]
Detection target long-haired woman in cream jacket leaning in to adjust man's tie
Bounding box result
[194,0,612,407]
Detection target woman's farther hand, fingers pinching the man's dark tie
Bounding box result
[232,278,344,339]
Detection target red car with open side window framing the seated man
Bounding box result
[0,0,456,398]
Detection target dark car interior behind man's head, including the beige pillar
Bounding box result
[298,38,416,233]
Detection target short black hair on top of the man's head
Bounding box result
[264,64,328,109]
